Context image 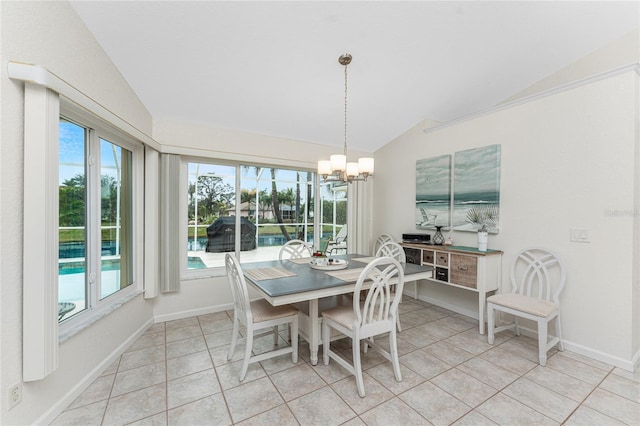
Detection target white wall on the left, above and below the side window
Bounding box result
[0,1,152,425]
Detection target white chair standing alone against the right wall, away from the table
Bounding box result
[487,247,567,366]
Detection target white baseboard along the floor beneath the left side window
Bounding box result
[34,319,153,425]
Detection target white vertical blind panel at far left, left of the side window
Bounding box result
[22,83,60,382]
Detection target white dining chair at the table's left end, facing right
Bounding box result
[225,253,298,382]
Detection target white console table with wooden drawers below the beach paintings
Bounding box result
[401,243,502,334]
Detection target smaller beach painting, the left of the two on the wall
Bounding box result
[415,155,451,229]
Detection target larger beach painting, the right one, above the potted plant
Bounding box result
[452,145,500,233]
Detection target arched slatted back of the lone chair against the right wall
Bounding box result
[511,248,566,303]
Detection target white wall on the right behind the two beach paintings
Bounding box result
[373,69,640,368]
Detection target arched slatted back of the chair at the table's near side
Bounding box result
[353,257,404,328]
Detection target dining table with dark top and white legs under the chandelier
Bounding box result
[241,254,433,365]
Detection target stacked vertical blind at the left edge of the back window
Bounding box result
[160,154,180,293]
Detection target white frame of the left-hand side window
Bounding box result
[57,100,144,332]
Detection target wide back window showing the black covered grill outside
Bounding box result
[186,162,322,271]
